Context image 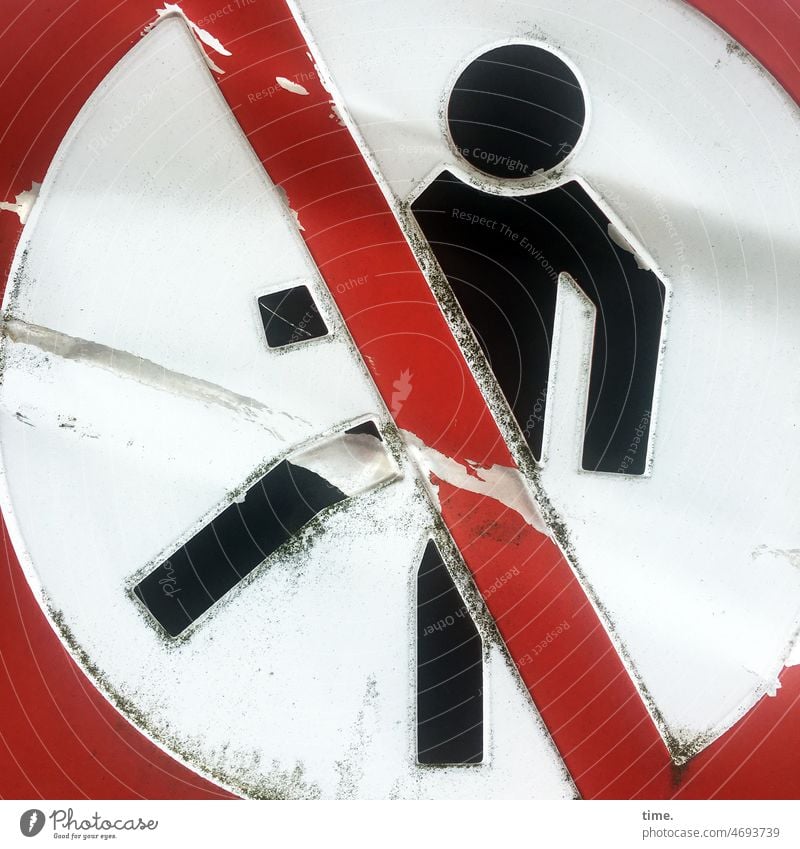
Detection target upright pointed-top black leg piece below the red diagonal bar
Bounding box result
[417,540,483,765]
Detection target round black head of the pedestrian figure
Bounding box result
[447,44,586,180]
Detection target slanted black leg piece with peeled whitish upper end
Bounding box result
[133,423,396,637]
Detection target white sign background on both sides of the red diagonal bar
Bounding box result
[0,0,800,798]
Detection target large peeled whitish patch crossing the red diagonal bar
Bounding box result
[401,430,550,536]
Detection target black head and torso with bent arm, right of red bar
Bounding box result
[412,44,666,475]
